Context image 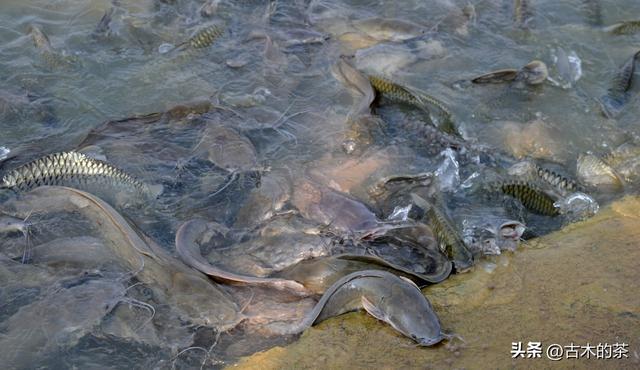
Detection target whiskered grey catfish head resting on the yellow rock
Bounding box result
[363,277,444,346]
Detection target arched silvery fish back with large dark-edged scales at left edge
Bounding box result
[0,152,148,192]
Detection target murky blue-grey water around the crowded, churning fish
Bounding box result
[0,0,640,368]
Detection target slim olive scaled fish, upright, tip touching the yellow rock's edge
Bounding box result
[425,206,473,272]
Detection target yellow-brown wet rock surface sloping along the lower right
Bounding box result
[232,197,640,370]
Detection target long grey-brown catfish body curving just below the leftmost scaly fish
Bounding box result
[2,186,244,330]
